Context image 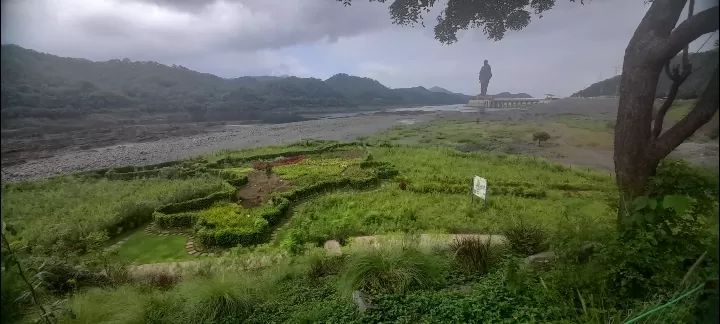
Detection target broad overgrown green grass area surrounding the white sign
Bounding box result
[281,147,615,243]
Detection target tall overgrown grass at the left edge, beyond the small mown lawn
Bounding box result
[2,176,227,246]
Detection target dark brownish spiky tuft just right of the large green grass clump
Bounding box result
[450,236,500,274]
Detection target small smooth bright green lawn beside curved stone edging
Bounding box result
[114,231,195,264]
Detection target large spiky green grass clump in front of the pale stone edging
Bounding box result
[340,249,445,294]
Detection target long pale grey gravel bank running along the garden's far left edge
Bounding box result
[2,113,436,182]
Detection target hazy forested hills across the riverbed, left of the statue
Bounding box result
[2,45,468,128]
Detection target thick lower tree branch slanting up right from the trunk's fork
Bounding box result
[650,67,720,161]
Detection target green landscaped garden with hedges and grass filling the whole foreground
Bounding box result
[2,137,717,323]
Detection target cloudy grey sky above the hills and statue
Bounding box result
[0,0,717,97]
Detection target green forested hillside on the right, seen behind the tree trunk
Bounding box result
[572,48,718,99]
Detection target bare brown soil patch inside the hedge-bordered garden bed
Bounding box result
[235,171,293,208]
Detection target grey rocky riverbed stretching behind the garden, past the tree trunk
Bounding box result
[2,98,718,182]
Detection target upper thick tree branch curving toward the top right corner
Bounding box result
[658,6,720,62]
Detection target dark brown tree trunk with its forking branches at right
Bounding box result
[614,0,718,228]
